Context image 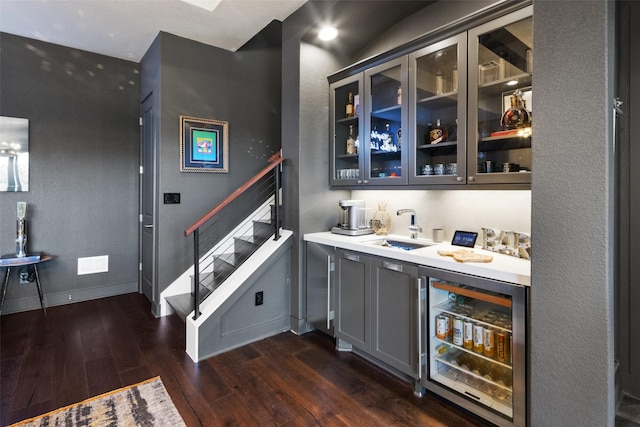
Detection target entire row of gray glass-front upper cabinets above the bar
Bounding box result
[329,6,533,189]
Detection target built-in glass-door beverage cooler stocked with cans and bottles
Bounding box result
[420,267,529,426]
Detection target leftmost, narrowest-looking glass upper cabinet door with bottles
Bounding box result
[330,74,365,186]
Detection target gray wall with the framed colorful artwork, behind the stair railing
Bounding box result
[141,27,281,308]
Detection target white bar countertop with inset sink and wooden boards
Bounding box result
[304,231,531,286]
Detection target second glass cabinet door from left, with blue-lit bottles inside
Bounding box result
[361,56,409,185]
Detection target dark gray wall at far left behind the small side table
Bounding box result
[0,33,139,313]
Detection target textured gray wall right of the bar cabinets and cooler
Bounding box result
[531,0,615,426]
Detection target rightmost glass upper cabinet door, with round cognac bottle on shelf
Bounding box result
[467,6,533,184]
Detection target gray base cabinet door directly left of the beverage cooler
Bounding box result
[371,258,421,378]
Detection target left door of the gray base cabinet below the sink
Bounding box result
[336,251,371,353]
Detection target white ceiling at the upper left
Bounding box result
[0,0,306,62]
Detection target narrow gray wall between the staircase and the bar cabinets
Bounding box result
[282,2,350,332]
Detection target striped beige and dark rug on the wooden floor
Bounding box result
[13,377,185,427]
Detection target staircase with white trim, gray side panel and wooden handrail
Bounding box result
[160,153,292,361]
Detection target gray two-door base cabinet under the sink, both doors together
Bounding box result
[336,251,422,378]
